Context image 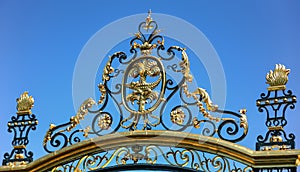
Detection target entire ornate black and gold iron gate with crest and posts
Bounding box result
[0,13,300,171]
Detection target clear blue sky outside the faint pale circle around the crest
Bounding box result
[0,0,300,165]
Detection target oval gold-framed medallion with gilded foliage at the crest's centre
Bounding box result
[121,56,166,129]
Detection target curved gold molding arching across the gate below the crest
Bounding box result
[0,130,300,172]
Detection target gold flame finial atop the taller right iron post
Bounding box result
[266,64,290,91]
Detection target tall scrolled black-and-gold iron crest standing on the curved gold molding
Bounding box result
[44,11,248,152]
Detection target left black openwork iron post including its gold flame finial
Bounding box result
[2,92,38,166]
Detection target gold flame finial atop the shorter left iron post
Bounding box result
[17,91,34,114]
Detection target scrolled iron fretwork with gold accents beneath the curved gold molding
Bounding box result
[49,145,252,172]
